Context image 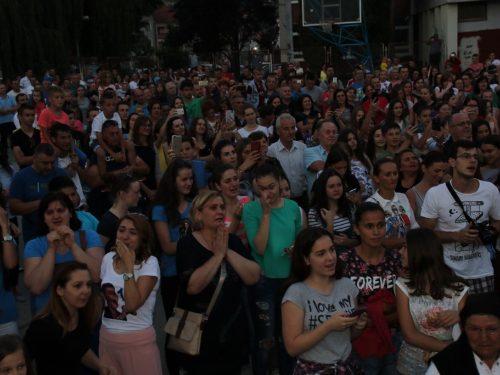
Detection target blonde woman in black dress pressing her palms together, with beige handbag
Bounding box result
[177,191,260,375]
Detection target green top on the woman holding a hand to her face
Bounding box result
[243,199,302,279]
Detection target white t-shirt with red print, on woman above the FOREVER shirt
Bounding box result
[366,190,419,238]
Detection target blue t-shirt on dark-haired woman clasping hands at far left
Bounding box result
[24,230,103,313]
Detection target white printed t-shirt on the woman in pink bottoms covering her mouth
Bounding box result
[101,251,160,333]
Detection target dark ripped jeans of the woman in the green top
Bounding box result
[248,275,294,375]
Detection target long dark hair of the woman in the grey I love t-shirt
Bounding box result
[283,228,344,293]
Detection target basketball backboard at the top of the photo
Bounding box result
[302,0,362,26]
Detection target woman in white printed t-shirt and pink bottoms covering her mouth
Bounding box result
[99,214,162,375]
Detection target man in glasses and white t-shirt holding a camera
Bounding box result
[421,140,500,294]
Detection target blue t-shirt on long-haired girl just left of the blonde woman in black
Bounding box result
[152,202,191,277]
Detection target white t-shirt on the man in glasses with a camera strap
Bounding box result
[420,180,500,279]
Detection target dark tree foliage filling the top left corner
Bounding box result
[0,0,163,77]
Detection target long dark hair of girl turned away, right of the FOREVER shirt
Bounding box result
[406,227,465,300]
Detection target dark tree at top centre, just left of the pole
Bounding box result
[174,0,277,78]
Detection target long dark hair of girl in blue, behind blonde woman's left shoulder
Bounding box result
[150,160,198,226]
